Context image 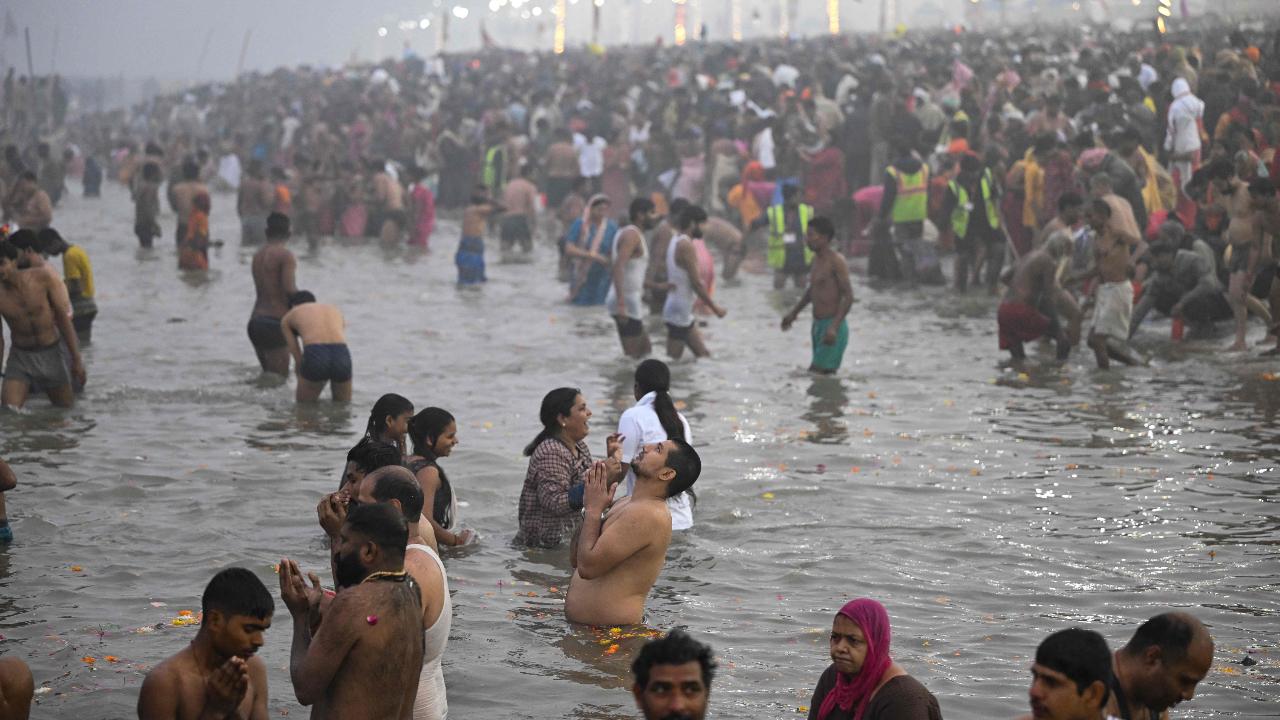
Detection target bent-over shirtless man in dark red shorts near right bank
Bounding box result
[996,236,1080,369]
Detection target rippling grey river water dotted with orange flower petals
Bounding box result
[0,180,1280,719]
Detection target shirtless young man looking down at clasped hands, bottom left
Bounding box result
[138,568,275,720]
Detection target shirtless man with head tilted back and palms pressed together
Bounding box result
[564,439,703,626]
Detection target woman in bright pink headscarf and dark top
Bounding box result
[809,597,942,720]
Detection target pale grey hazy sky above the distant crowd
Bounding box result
[0,0,957,79]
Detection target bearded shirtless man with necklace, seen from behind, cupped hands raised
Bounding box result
[280,503,422,720]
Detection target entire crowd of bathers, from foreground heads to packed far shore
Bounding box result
[0,9,1280,720]
